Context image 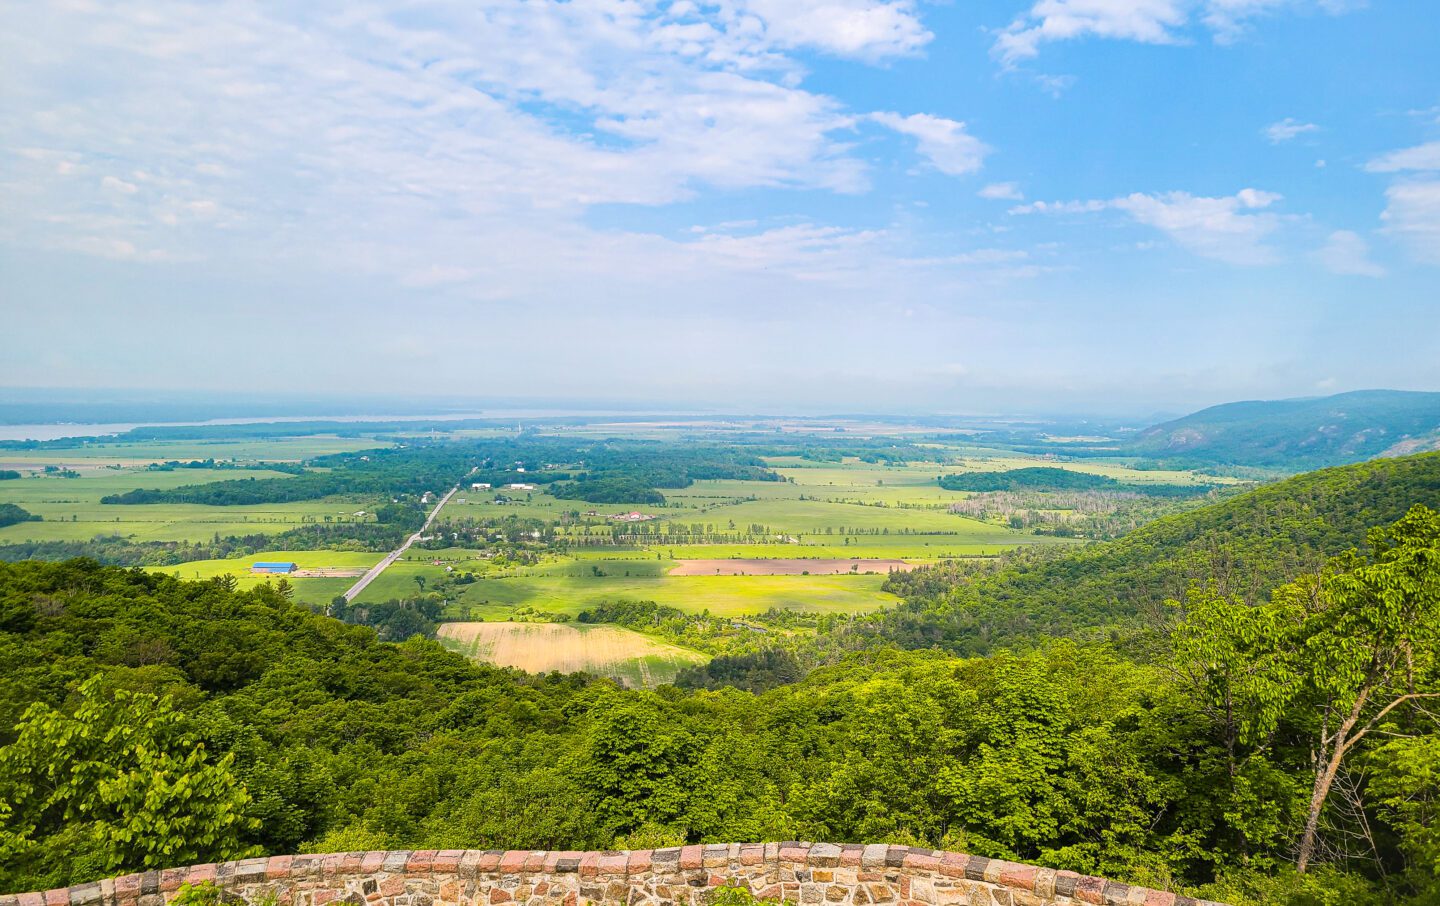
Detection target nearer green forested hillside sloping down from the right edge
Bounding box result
[861,454,1440,652]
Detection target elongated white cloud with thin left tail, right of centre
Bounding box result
[1011,189,1280,265]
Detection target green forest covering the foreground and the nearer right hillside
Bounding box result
[0,455,1440,905]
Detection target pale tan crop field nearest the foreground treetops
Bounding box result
[439,622,708,687]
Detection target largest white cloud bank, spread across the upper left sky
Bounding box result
[0,0,986,286]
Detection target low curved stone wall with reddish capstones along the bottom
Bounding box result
[0,843,1232,906]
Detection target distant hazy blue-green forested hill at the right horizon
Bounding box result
[1129,390,1440,471]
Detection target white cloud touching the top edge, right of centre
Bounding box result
[992,0,1354,66]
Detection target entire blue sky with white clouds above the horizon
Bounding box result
[0,0,1440,413]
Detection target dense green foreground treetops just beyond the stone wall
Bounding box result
[0,535,1440,903]
